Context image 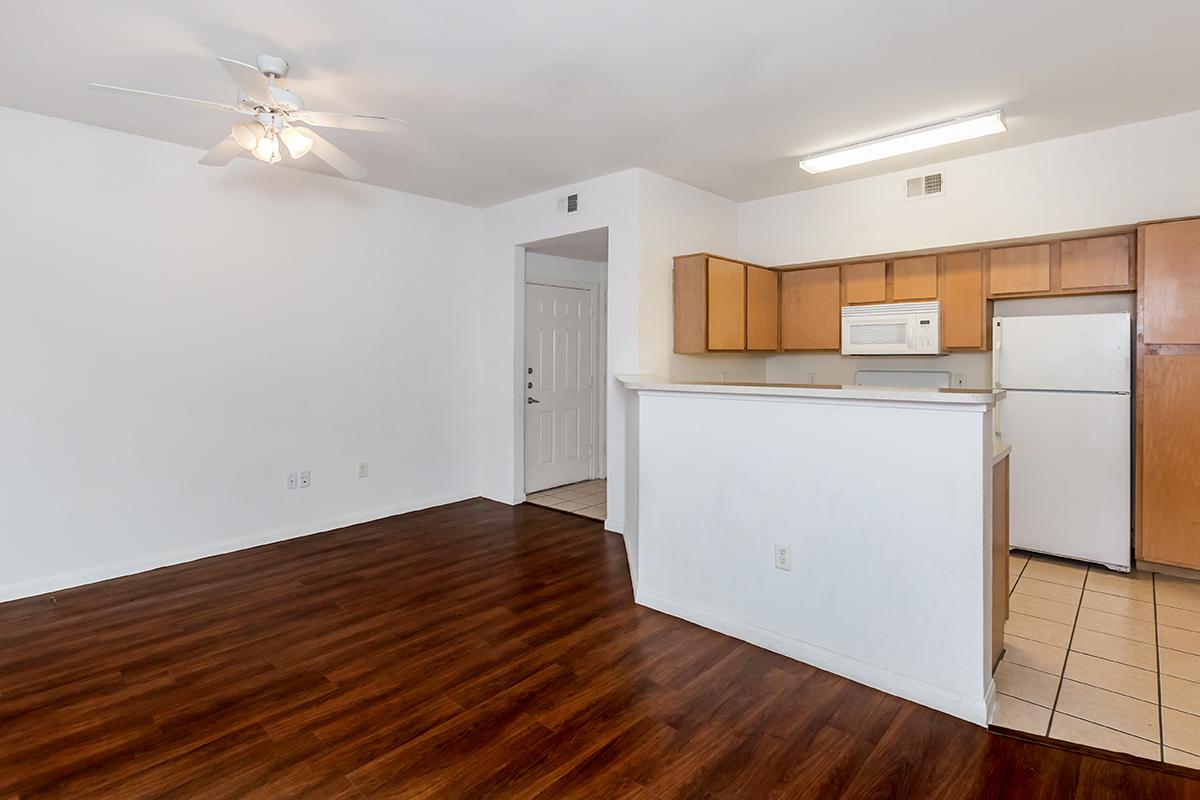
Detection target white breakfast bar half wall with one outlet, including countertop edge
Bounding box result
[619,375,1003,724]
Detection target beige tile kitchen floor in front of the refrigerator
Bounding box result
[992,551,1200,769]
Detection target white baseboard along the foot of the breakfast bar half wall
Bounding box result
[635,589,995,727]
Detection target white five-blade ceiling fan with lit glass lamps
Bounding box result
[88,55,412,180]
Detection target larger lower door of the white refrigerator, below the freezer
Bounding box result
[997,391,1130,569]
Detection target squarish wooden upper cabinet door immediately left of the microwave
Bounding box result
[780,266,841,350]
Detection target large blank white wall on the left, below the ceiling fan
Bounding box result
[0,108,482,600]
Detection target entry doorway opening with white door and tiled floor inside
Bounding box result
[520,229,608,519]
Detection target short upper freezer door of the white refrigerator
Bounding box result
[992,312,1133,392]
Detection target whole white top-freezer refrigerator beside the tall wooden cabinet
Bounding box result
[992,313,1133,571]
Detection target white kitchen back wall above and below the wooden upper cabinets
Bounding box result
[738,112,1200,385]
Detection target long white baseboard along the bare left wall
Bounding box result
[0,493,478,602]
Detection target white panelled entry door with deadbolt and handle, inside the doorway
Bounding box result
[523,283,594,493]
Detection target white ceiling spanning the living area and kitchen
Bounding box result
[0,0,1200,205]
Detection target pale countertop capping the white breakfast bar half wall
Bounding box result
[617,374,1004,405]
